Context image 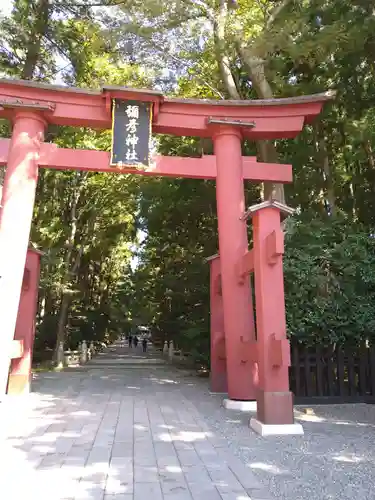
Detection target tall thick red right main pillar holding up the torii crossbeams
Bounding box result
[213,125,256,401]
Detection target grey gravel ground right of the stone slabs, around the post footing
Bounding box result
[180,379,375,500]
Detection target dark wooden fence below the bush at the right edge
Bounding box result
[289,344,375,404]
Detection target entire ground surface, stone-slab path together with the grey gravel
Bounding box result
[0,345,375,500]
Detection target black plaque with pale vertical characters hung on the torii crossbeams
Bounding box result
[111,99,151,167]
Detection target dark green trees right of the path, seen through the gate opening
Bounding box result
[133,175,217,355]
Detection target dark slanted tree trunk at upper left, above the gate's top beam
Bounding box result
[21,0,50,80]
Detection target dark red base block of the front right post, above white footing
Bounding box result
[257,390,294,425]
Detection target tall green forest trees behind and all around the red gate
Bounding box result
[0,0,375,366]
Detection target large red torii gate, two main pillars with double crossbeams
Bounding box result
[0,80,332,436]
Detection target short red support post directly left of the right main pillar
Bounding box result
[207,255,228,393]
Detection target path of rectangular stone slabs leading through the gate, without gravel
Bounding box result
[0,343,271,500]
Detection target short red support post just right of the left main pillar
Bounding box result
[7,248,41,394]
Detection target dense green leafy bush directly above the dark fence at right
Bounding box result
[284,214,375,345]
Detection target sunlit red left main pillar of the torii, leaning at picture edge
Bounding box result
[0,110,46,398]
